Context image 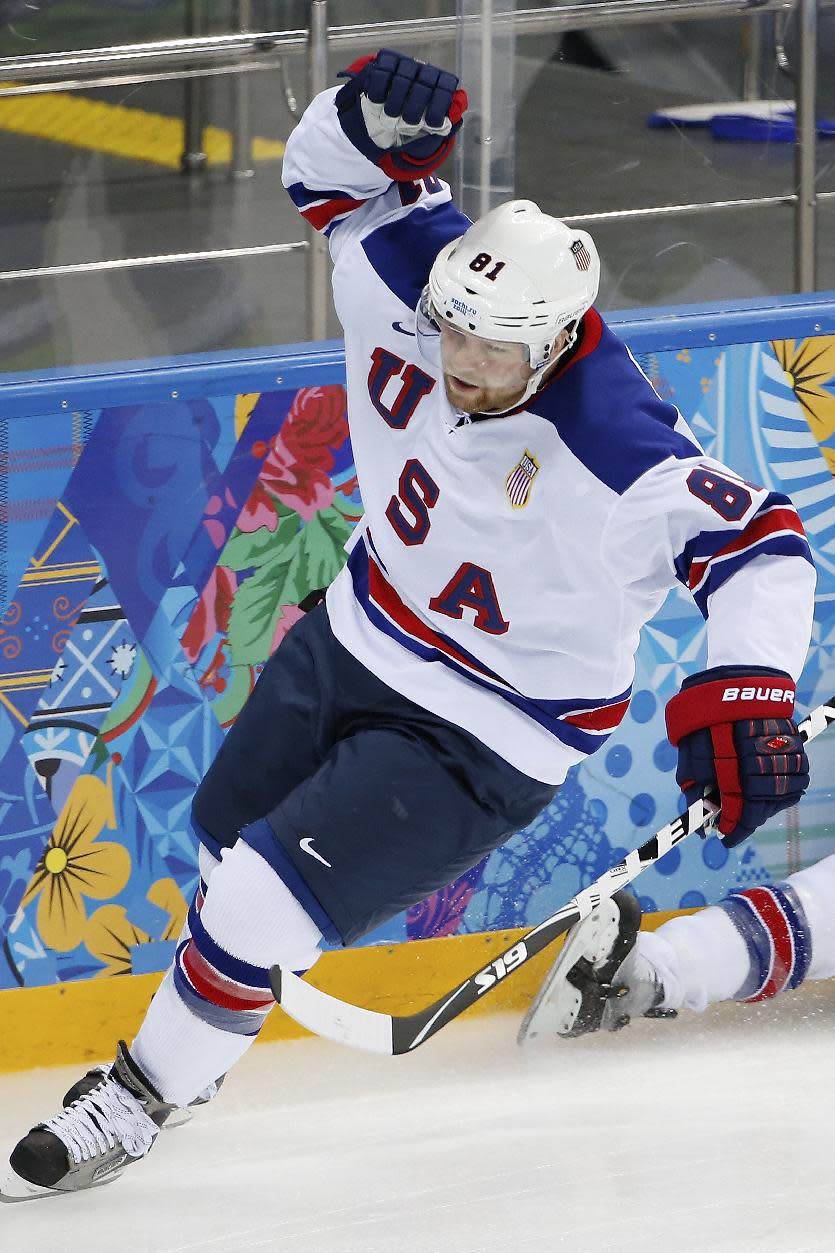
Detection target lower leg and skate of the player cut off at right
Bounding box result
[519,855,835,1042]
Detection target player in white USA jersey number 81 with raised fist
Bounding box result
[0,50,815,1197]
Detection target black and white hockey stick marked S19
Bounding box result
[270,695,835,1054]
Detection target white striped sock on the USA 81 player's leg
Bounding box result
[132,841,321,1105]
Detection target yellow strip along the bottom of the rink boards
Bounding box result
[0,910,693,1073]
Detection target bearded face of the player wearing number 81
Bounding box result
[440,326,533,413]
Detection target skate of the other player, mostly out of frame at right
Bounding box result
[519,891,676,1044]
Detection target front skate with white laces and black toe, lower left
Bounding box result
[0,1041,174,1202]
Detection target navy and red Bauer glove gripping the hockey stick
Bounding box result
[667,665,809,848]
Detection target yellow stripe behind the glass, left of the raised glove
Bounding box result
[0,84,285,169]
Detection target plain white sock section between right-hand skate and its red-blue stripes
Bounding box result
[637,906,750,1010]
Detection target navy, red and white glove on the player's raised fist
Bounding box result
[336,48,468,183]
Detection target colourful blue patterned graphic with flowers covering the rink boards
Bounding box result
[0,336,835,987]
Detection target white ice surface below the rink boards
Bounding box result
[0,982,835,1253]
